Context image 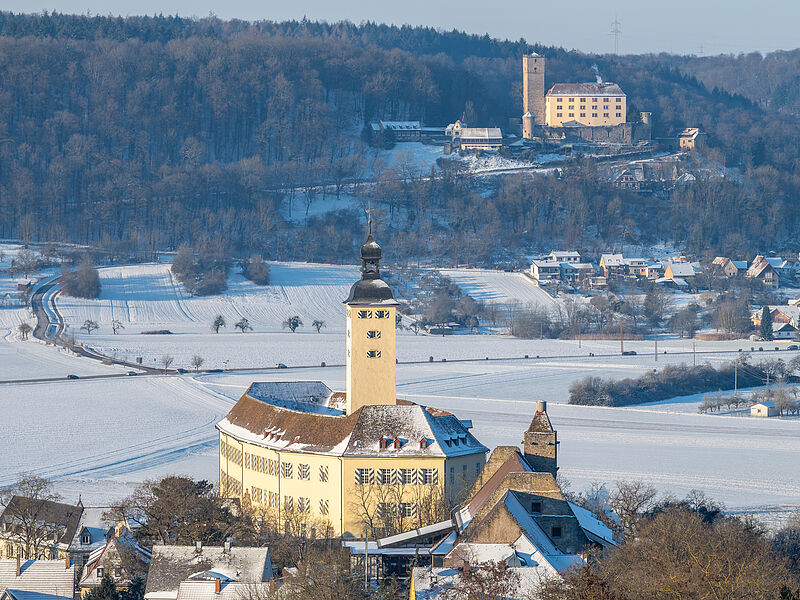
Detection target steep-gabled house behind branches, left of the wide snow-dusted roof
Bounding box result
[78,523,151,597]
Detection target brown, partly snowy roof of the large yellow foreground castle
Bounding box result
[217,382,487,457]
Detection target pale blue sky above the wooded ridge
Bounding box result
[6,0,800,55]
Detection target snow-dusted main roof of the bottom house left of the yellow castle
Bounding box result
[145,545,273,600]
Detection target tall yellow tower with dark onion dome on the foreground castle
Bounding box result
[344,220,397,415]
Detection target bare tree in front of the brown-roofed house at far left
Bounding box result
[0,474,63,559]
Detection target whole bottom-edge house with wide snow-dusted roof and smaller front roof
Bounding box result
[144,542,274,600]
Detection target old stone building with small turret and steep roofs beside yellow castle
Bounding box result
[344,402,615,598]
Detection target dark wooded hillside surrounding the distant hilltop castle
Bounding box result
[0,13,800,260]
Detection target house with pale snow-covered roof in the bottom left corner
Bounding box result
[0,556,75,600]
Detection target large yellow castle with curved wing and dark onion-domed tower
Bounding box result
[217,227,488,537]
